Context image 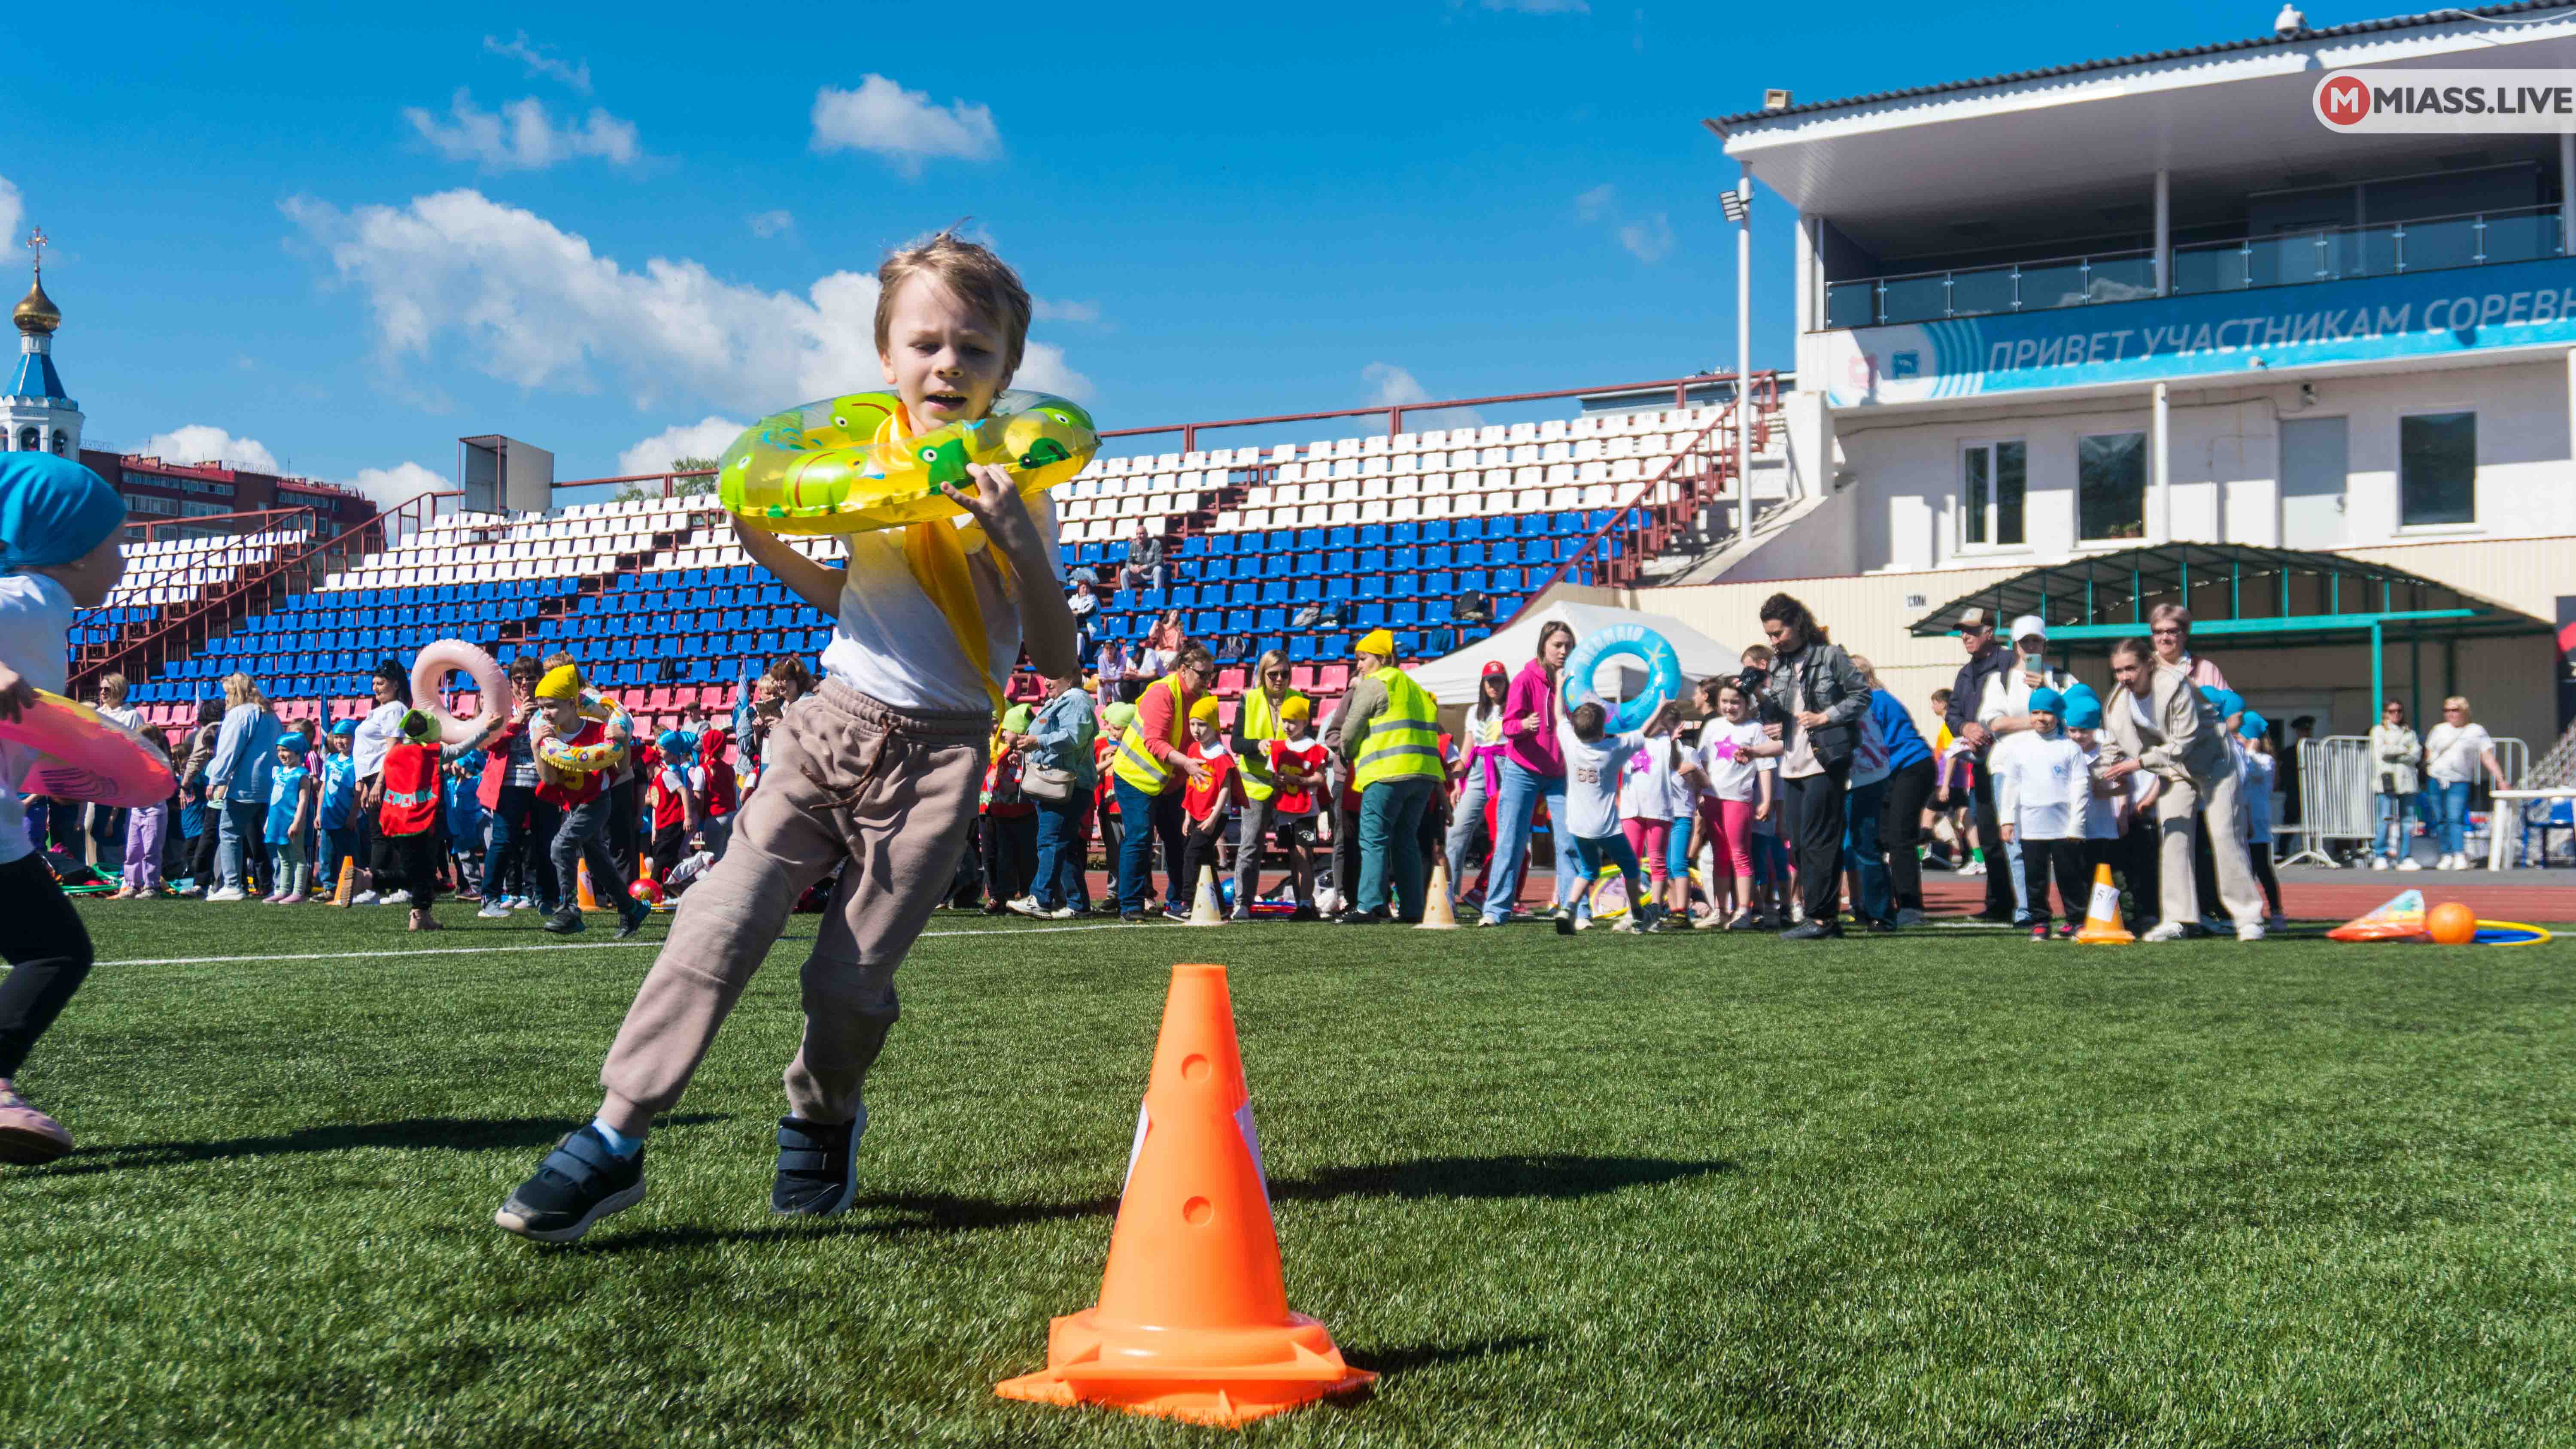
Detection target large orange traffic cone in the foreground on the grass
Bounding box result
[994,965,1378,1428]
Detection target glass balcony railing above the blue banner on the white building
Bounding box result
[1824,206,2566,327]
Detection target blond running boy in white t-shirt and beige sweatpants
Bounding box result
[492,232,1077,1243]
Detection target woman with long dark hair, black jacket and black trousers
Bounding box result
[1762,594,1870,942]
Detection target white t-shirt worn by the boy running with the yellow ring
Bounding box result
[822,494,1064,713]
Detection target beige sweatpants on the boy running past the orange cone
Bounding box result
[600,679,992,1125]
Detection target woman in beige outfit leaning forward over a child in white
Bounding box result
[2094,638,2264,942]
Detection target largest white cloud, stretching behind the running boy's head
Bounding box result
[286,191,1090,417]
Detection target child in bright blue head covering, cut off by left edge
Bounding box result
[0,453,126,1163]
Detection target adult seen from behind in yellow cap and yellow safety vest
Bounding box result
[1324,628,1448,927]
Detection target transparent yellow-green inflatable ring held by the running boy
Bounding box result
[716,391,1100,533]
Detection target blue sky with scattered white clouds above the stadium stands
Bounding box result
[0,0,2360,494]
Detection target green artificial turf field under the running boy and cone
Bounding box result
[0,903,2576,1446]
